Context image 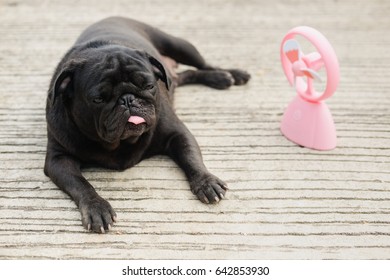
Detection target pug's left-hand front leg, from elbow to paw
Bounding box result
[45,151,116,233]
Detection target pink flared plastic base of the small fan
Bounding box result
[280,95,337,150]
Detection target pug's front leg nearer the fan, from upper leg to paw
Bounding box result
[165,119,227,203]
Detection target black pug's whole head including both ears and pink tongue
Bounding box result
[48,45,169,144]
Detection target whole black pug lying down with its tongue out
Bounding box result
[44,17,250,233]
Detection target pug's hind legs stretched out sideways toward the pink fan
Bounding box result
[149,29,250,89]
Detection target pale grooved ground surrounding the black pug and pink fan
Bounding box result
[0,0,390,259]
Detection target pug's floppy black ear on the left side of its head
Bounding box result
[49,60,85,106]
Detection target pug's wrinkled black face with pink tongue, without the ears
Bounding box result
[70,47,160,143]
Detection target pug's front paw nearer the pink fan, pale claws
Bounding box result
[190,174,228,204]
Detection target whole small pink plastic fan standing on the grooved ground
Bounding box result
[280,26,339,150]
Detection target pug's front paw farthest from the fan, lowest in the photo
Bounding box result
[79,196,116,233]
